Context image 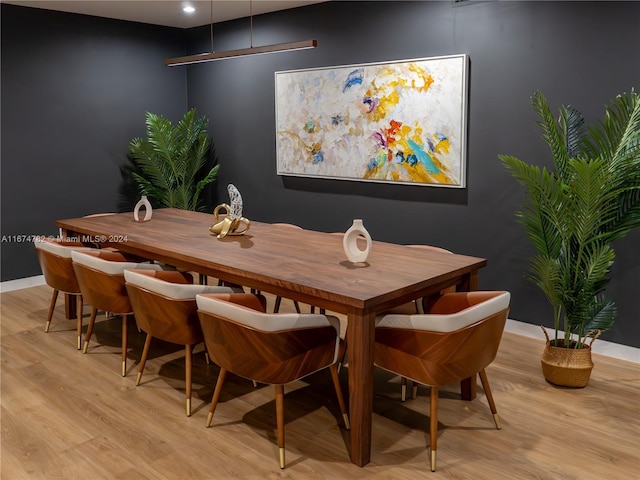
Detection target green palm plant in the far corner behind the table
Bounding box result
[129,109,219,210]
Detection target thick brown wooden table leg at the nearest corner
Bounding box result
[347,311,375,467]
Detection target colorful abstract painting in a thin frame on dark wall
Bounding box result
[275,54,468,188]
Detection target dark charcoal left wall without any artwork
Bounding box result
[1,4,186,281]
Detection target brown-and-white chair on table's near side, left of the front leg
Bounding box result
[196,294,350,468]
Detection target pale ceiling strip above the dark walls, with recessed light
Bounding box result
[0,0,327,28]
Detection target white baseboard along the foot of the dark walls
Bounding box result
[0,275,640,363]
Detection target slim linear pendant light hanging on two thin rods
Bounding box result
[164,0,318,67]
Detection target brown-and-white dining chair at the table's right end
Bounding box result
[374,291,511,471]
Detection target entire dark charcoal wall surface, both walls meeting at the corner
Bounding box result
[2,1,640,347]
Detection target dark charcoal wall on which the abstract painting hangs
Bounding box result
[180,2,640,346]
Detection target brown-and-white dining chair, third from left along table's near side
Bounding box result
[124,270,244,417]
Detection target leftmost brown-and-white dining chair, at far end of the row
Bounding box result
[33,237,91,350]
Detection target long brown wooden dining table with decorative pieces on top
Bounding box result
[56,208,486,466]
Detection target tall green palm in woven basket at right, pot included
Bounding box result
[499,90,640,387]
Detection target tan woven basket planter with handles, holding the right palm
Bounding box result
[540,328,599,388]
